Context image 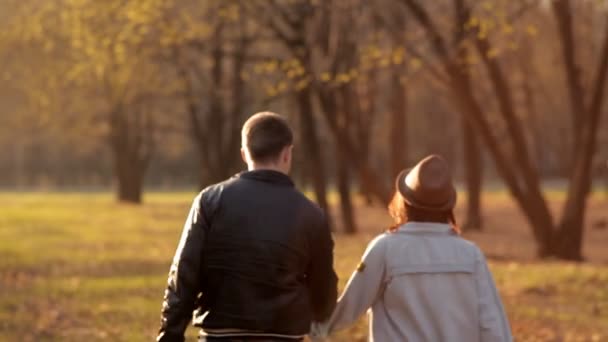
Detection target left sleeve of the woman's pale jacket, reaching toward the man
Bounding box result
[320,235,386,335]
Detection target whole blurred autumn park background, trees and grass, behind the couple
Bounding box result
[0,0,608,341]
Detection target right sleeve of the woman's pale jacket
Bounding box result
[475,251,513,342]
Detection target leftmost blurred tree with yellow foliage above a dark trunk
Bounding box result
[20,0,178,203]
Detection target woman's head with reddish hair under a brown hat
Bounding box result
[388,155,458,232]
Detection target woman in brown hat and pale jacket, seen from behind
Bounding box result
[313,155,512,342]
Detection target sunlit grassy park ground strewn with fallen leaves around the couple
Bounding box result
[0,193,608,341]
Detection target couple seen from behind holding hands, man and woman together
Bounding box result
[157,112,512,342]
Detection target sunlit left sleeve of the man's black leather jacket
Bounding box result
[157,193,207,342]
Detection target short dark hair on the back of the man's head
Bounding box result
[241,112,293,163]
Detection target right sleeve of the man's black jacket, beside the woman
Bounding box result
[307,212,338,321]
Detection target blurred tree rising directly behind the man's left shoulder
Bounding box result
[166,3,255,187]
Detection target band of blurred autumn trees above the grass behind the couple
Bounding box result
[0,0,608,260]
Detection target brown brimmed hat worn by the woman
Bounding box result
[396,155,456,211]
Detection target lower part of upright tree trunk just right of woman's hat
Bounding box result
[462,115,483,230]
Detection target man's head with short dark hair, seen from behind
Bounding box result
[241,112,293,174]
